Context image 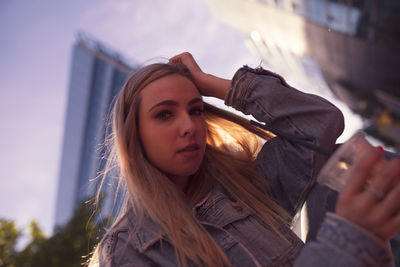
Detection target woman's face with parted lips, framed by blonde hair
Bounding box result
[139,74,207,185]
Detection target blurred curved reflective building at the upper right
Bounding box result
[208,0,400,151]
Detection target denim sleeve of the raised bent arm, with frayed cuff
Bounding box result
[225,66,344,219]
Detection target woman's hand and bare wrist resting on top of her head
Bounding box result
[169,52,231,100]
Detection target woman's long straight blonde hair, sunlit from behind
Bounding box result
[91,64,289,266]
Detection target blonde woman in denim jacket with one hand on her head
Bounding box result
[93,53,400,266]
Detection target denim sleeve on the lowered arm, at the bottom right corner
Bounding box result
[294,212,394,267]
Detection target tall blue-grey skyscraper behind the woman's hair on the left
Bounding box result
[55,33,133,229]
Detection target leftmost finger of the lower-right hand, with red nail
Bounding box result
[342,147,383,195]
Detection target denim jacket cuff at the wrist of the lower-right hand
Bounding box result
[317,212,393,266]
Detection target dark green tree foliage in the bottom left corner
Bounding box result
[0,201,108,267]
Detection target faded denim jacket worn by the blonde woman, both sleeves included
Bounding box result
[99,66,392,267]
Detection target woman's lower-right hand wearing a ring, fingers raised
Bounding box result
[336,148,400,246]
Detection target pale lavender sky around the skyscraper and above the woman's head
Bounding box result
[0,0,362,243]
